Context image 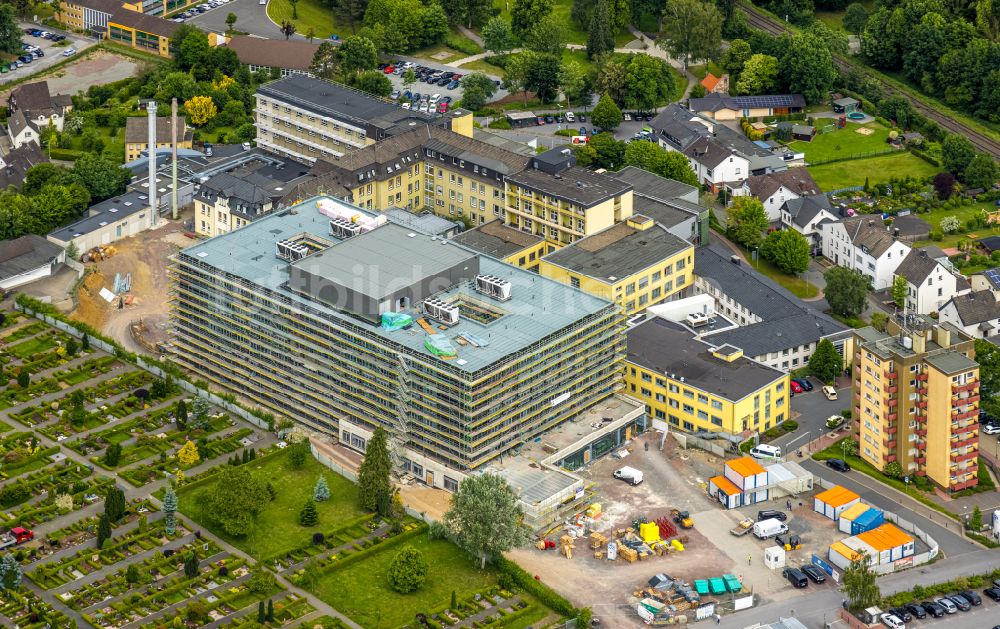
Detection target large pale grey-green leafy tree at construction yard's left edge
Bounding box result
[444,473,529,569]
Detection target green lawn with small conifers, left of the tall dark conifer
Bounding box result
[178,450,364,559]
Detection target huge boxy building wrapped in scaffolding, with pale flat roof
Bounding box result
[171,197,624,485]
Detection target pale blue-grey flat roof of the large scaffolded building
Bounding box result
[178,196,613,372]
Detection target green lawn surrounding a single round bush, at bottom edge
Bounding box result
[313,535,496,627]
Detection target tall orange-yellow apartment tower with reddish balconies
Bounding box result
[852,316,980,491]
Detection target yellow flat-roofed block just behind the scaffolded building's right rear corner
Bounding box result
[539,214,694,315]
